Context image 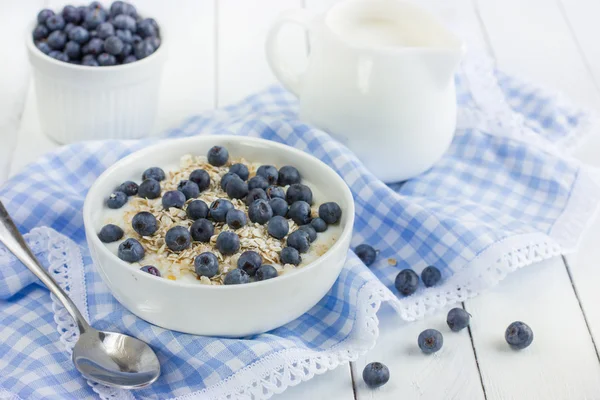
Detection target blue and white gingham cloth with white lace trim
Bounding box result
[0,66,599,399]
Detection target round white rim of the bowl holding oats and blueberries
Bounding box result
[83,135,355,290]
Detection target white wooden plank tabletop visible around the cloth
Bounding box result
[0,0,600,400]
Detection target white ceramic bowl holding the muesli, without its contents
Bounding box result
[83,135,354,337]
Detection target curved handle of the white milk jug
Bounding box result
[266,8,315,96]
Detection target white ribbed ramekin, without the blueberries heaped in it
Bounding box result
[26,22,168,144]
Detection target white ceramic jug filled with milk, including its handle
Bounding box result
[266,0,464,182]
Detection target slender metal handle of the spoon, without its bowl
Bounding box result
[0,202,90,333]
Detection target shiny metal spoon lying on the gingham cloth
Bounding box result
[0,202,160,389]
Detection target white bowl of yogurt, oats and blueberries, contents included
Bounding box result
[83,135,354,337]
